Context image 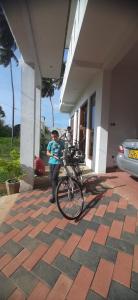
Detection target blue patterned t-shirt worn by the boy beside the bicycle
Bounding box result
[47,141,64,165]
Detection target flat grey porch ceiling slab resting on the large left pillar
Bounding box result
[1,0,70,86]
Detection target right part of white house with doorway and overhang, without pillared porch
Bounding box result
[60,0,138,173]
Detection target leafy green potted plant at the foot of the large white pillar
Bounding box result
[0,150,24,195]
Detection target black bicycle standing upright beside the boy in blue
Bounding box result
[56,146,84,220]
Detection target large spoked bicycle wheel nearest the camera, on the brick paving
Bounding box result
[56,176,84,220]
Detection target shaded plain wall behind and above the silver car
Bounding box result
[107,66,138,166]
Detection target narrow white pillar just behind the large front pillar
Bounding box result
[35,88,41,156]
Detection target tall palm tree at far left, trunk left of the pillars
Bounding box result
[0,7,18,144]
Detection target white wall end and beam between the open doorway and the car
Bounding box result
[72,71,111,173]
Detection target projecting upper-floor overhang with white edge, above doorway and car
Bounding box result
[60,0,138,113]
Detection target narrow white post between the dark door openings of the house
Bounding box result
[85,98,91,159]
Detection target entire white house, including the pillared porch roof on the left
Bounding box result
[1,0,138,190]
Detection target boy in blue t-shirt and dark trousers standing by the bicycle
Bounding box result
[47,130,64,203]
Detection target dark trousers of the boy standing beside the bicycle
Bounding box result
[50,164,60,199]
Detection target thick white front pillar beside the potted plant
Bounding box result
[20,63,36,191]
